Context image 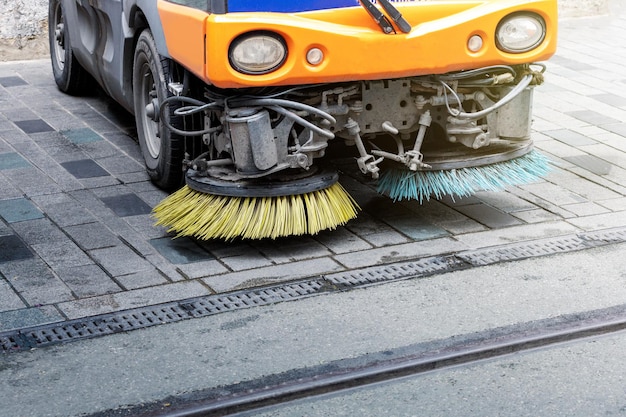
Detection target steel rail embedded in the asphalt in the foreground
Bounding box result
[133,306,626,417]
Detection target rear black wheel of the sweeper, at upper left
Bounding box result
[48,0,92,95]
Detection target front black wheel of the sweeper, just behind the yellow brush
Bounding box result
[133,29,185,190]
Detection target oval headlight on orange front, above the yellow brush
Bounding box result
[228,32,287,75]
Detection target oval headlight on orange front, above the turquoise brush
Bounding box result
[496,13,546,54]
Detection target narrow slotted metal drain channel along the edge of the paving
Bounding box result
[0,228,626,353]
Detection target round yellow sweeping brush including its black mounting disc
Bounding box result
[153,167,358,240]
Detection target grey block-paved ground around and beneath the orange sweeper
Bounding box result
[0,10,626,332]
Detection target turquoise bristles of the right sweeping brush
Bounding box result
[378,151,550,203]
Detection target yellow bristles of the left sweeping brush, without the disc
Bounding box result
[153,183,359,240]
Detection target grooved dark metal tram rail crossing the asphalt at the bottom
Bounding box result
[90,305,626,417]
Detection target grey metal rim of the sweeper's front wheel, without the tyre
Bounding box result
[139,62,161,159]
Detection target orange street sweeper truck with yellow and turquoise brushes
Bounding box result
[49,0,557,240]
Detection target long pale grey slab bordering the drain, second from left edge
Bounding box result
[58,281,210,319]
